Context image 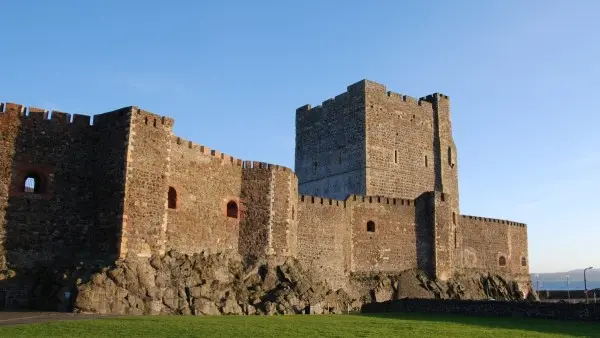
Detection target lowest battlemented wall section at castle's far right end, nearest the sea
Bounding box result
[460,215,529,275]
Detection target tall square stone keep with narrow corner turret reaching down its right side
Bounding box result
[295,80,461,277]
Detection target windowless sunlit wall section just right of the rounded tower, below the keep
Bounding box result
[298,196,351,288]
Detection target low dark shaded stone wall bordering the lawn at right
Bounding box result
[361,299,600,321]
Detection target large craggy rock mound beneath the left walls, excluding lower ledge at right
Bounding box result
[75,251,361,315]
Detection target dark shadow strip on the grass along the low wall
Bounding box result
[357,312,600,337]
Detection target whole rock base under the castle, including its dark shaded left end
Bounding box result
[0,251,537,315]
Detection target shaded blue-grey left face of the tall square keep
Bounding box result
[295,81,365,200]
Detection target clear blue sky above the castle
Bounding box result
[0,0,600,272]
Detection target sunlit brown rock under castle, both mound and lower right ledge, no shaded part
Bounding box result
[74,251,536,315]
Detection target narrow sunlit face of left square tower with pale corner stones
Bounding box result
[120,107,174,257]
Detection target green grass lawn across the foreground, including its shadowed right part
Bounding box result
[0,313,600,338]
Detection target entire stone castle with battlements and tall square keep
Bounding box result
[0,80,529,287]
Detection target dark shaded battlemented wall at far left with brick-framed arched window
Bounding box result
[0,104,105,269]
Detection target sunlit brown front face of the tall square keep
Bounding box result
[366,84,435,199]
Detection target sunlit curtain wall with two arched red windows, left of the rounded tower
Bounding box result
[166,138,244,253]
